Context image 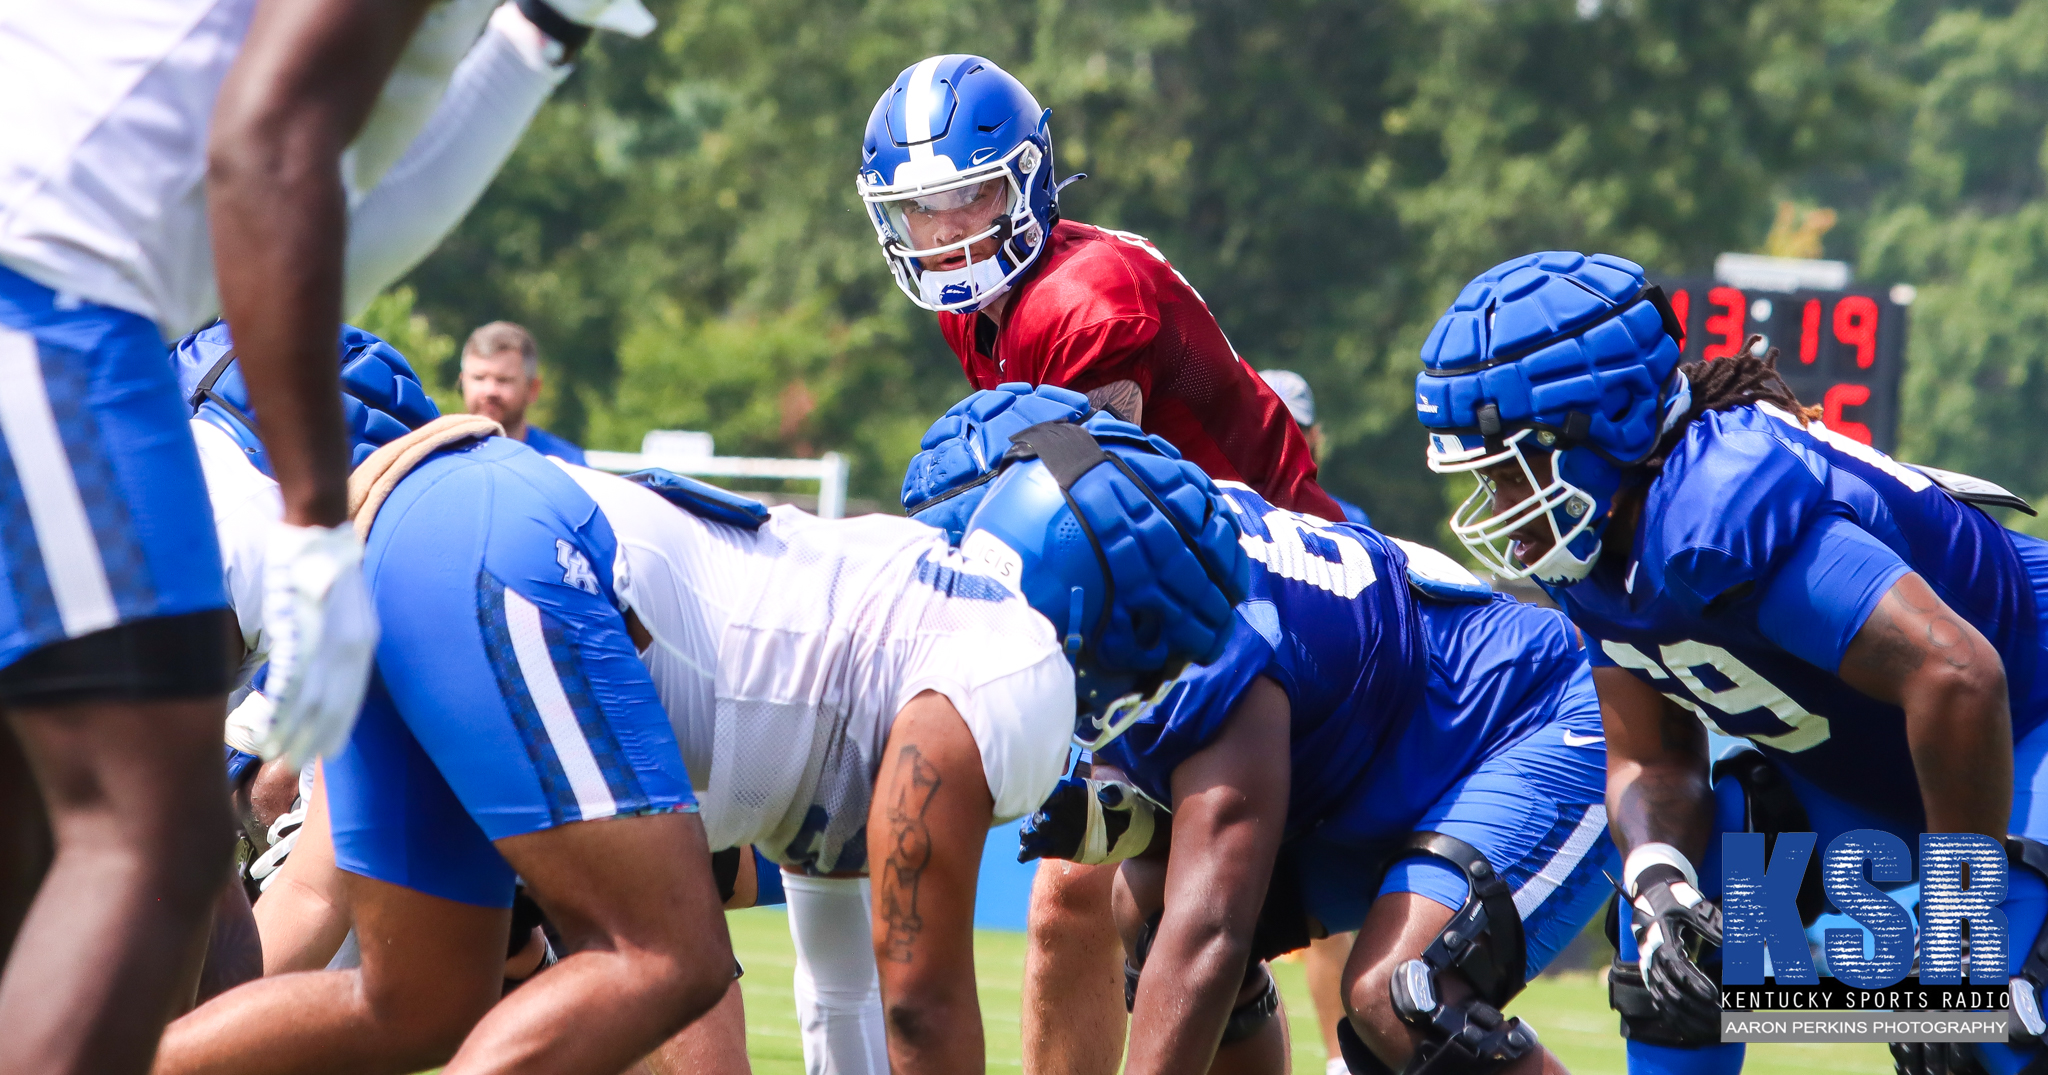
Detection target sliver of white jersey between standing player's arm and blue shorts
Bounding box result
[190,418,285,688]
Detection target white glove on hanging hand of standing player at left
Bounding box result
[260,522,377,766]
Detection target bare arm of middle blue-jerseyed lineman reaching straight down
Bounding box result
[1124,676,1290,1075]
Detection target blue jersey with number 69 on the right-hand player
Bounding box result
[1548,403,2048,831]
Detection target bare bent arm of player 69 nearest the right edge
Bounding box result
[1839,573,2013,840]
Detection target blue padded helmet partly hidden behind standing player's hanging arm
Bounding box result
[170,321,440,477]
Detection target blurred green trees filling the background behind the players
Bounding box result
[387,0,2048,536]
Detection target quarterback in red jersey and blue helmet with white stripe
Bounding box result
[860,55,1343,520]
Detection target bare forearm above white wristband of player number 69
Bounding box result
[1593,668,1714,862]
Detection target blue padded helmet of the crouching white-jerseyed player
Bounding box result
[961,414,1251,749]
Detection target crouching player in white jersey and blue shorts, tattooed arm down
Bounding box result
[160,416,1243,1073]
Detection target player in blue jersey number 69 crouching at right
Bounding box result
[1415,252,2048,1073]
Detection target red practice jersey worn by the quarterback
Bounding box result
[938,221,1343,520]
